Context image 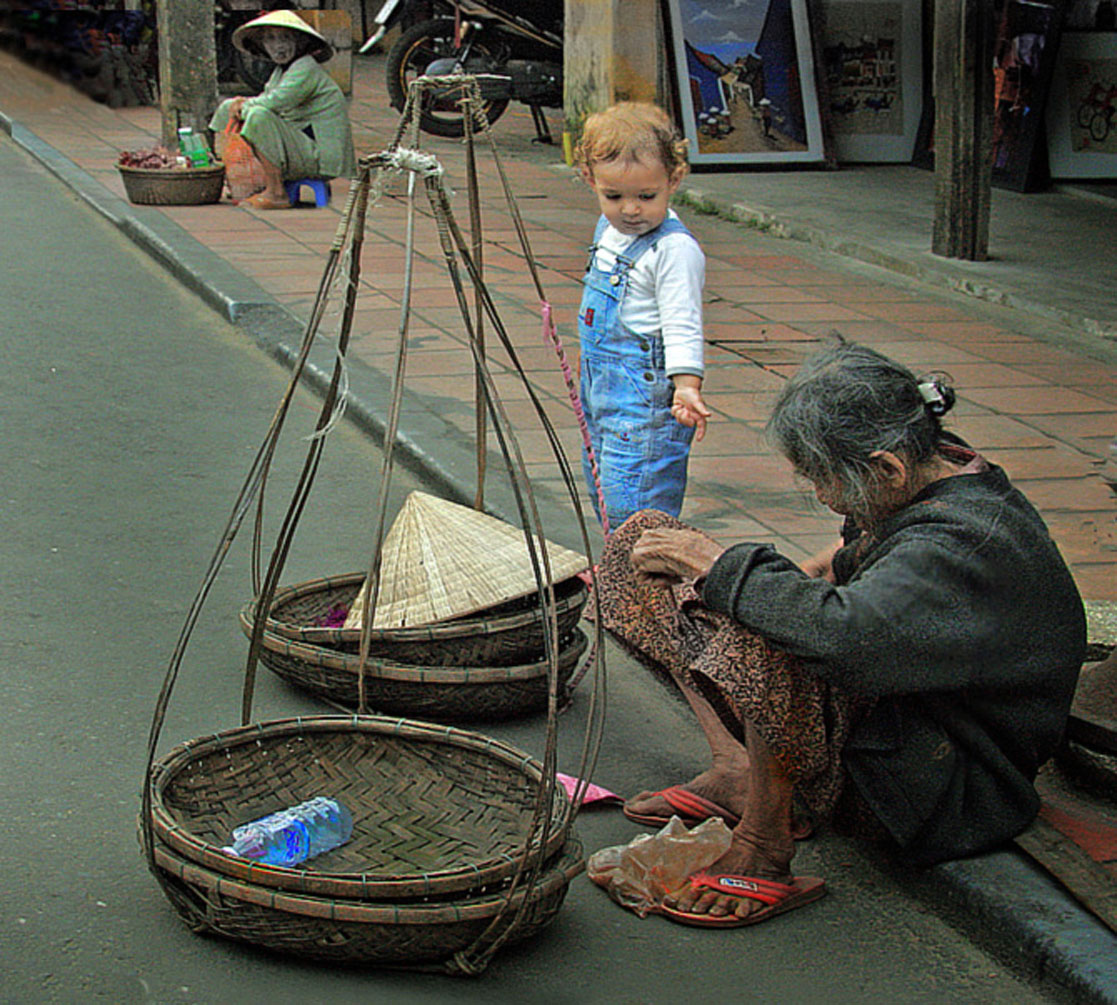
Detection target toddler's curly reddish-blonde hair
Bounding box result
[574,102,690,181]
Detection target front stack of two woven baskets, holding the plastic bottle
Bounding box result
[143,716,583,973]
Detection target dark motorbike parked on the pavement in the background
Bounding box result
[362,0,563,143]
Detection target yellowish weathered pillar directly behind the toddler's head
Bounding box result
[563,0,665,161]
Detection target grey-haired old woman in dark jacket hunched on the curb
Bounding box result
[599,344,1086,926]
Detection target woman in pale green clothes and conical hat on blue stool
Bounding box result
[209,10,356,210]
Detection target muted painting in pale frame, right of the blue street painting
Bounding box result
[820,0,923,163]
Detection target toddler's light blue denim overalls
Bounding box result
[577,217,694,530]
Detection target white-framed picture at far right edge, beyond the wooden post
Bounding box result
[1048,31,1117,180]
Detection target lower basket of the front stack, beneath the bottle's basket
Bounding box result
[154,838,583,972]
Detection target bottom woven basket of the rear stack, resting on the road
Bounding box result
[240,607,589,722]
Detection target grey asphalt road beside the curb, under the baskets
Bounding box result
[0,137,1063,1005]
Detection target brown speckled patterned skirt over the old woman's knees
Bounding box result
[598,510,866,817]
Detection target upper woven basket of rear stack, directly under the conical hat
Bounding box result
[250,573,589,667]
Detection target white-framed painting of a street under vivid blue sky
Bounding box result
[668,0,824,169]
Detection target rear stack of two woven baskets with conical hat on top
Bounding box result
[240,492,588,722]
